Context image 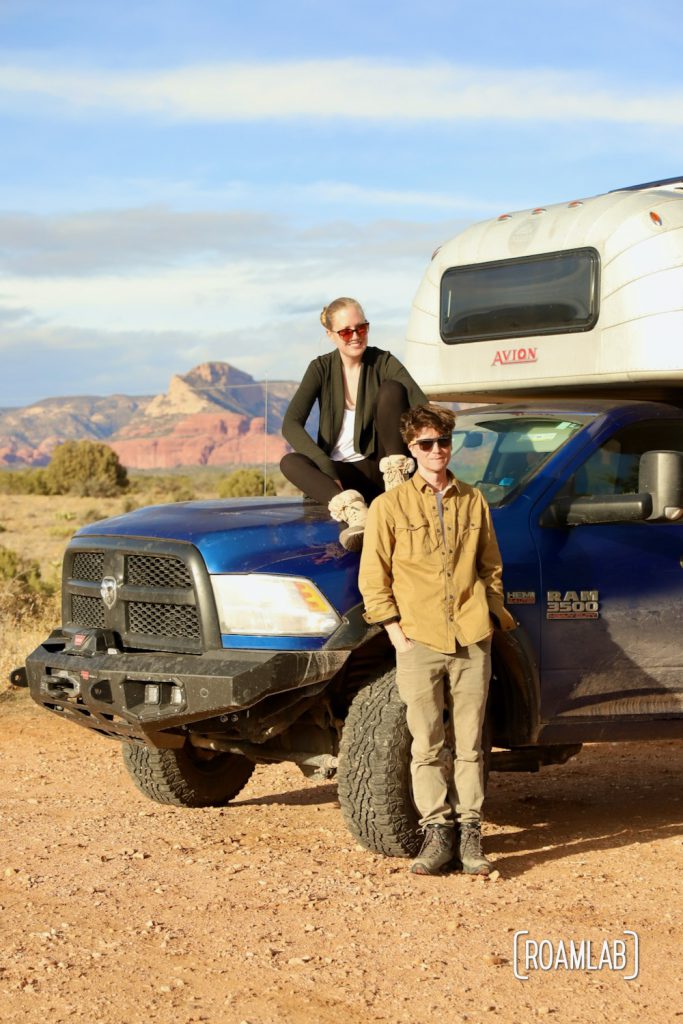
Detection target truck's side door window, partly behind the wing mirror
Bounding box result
[566,420,683,498]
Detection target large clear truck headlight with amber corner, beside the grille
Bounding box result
[211,572,341,637]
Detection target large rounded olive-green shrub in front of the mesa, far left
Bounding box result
[45,440,128,498]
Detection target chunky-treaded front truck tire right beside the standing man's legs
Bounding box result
[337,669,421,857]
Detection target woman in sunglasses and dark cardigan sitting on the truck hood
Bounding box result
[280,297,427,551]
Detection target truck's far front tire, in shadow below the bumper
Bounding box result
[123,743,255,807]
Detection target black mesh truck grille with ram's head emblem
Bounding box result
[62,537,220,653]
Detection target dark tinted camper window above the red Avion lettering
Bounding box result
[440,248,600,345]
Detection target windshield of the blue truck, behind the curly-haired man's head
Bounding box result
[449,411,583,506]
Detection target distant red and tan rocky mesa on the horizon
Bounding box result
[0,362,297,469]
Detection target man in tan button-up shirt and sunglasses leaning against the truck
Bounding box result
[358,407,515,874]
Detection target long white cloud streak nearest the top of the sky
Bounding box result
[0,58,683,126]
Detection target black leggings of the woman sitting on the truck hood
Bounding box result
[280,381,410,505]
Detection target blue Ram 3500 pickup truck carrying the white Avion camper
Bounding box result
[27,186,683,856]
